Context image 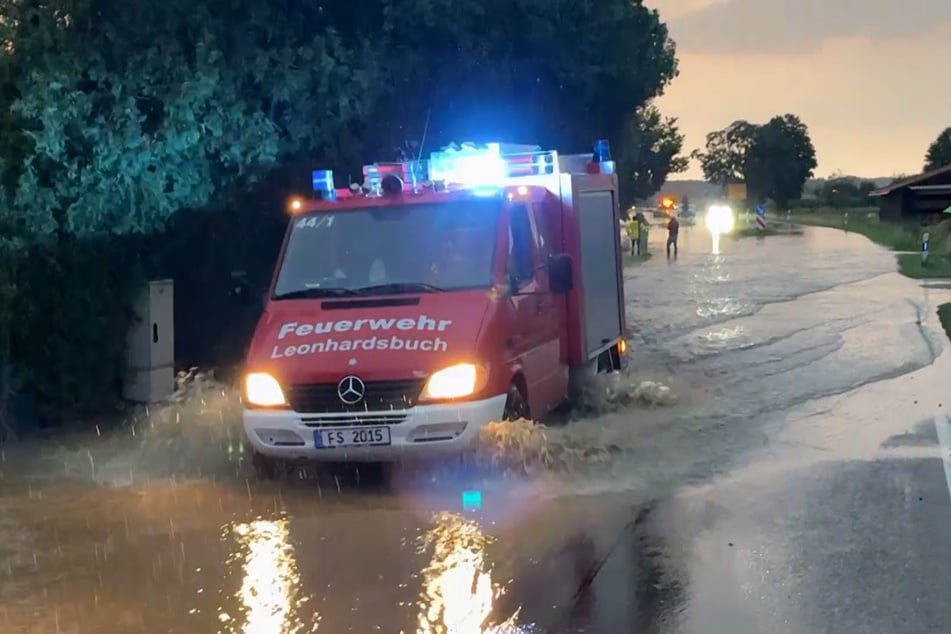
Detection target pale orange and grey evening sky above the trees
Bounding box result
[645,0,951,178]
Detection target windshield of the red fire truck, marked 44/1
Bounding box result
[274,200,501,299]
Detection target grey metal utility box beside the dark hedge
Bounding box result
[124,280,175,403]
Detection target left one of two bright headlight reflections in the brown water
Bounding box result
[219,519,319,634]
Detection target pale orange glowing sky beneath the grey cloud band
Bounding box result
[658,30,951,177]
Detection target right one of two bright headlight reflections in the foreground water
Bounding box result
[417,512,518,634]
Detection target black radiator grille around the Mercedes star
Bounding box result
[286,379,423,414]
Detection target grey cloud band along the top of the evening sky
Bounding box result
[654,0,951,55]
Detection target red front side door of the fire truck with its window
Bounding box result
[506,203,564,416]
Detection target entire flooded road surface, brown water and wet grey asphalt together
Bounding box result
[0,228,951,634]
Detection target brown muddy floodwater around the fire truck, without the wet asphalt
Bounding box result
[0,225,948,634]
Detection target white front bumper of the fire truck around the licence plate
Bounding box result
[243,394,505,462]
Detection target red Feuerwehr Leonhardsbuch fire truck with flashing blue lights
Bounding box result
[243,144,626,474]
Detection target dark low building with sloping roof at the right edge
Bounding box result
[869,165,951,220]
